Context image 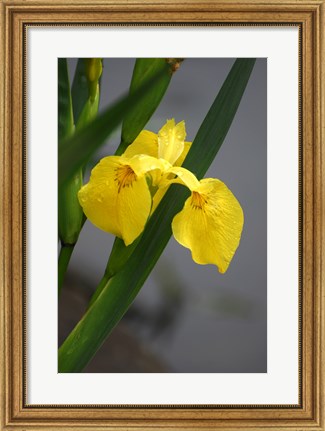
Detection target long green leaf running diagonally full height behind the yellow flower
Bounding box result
[59,59,255,372]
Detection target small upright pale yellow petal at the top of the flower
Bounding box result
[158,119,186,165]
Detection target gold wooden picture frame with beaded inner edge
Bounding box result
[0,0,325,431]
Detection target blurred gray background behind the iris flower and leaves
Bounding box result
[59,59,267,373]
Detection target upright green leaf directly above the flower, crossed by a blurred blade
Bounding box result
[116,58,181,155]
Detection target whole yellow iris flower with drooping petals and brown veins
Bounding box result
[78,120,244,273]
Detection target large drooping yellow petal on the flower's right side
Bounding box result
[172,178,244,273]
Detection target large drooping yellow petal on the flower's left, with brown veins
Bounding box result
[78,156,151,245]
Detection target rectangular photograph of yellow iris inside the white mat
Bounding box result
[58,58,267,373]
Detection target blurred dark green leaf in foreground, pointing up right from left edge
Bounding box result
[59,64,168,186]
